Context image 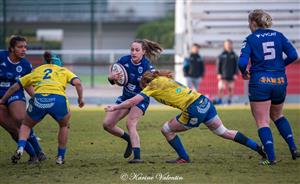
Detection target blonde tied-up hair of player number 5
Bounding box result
[248,9,272,28]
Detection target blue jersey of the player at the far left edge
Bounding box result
[0,51,32,97]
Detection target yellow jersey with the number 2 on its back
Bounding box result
[19,64,78,96]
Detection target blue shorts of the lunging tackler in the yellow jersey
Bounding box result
[176,95,217,128]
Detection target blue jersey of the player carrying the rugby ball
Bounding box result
[117,55,154,98]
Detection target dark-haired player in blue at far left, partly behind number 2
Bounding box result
[0,36,46,163]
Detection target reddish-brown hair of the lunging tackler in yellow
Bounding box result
[140,70,174,88]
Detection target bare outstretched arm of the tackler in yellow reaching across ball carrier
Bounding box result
[104,94,144,112]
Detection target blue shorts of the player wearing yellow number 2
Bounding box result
[27,94,69,122]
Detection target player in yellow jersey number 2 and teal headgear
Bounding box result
[0,52,84,164]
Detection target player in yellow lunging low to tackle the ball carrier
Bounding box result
[105,71,265,163]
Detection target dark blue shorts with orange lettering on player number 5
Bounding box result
[249,73,287,104]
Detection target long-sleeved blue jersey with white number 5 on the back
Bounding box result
[239,29,298,73]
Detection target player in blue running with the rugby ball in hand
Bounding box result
[103,39,162,163]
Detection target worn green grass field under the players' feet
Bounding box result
[0,108,300,184]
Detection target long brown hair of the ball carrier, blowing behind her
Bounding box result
[132,39,163,61]
